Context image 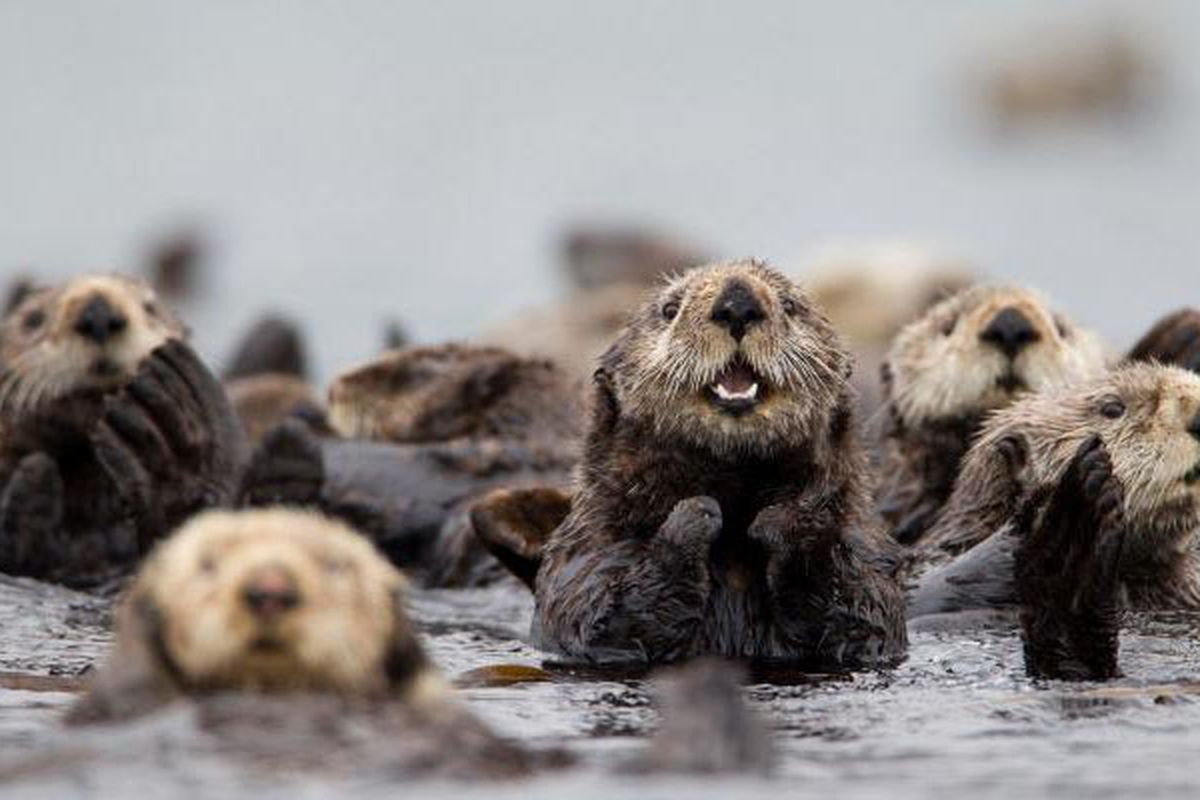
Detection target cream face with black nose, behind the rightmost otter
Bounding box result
[888,287,1105,426]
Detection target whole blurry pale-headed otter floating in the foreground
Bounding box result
[68,510,547,775]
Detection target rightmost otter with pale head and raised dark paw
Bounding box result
[911,363,1200,678]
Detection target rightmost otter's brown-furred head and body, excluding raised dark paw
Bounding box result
[917,365,1200,609]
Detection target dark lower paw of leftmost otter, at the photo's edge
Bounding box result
[0,452,62,576]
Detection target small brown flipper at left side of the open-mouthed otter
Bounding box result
[470,488,571,590]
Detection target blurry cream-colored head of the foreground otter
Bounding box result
[134,510,415,693]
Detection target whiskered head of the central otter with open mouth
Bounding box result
[598,260,851,453]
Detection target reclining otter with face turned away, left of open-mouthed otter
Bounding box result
[246,344,580,585]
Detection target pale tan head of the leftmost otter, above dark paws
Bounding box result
[0,275,186,420]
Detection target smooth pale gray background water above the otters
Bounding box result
[0,0,1200,377]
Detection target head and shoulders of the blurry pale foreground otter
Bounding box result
[73,510,445,720]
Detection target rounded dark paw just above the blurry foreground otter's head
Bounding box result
[238,420,325,506]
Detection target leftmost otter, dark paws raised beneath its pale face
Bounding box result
[0,276,244,585]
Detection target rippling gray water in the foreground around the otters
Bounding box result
[7,582,1200,800]
